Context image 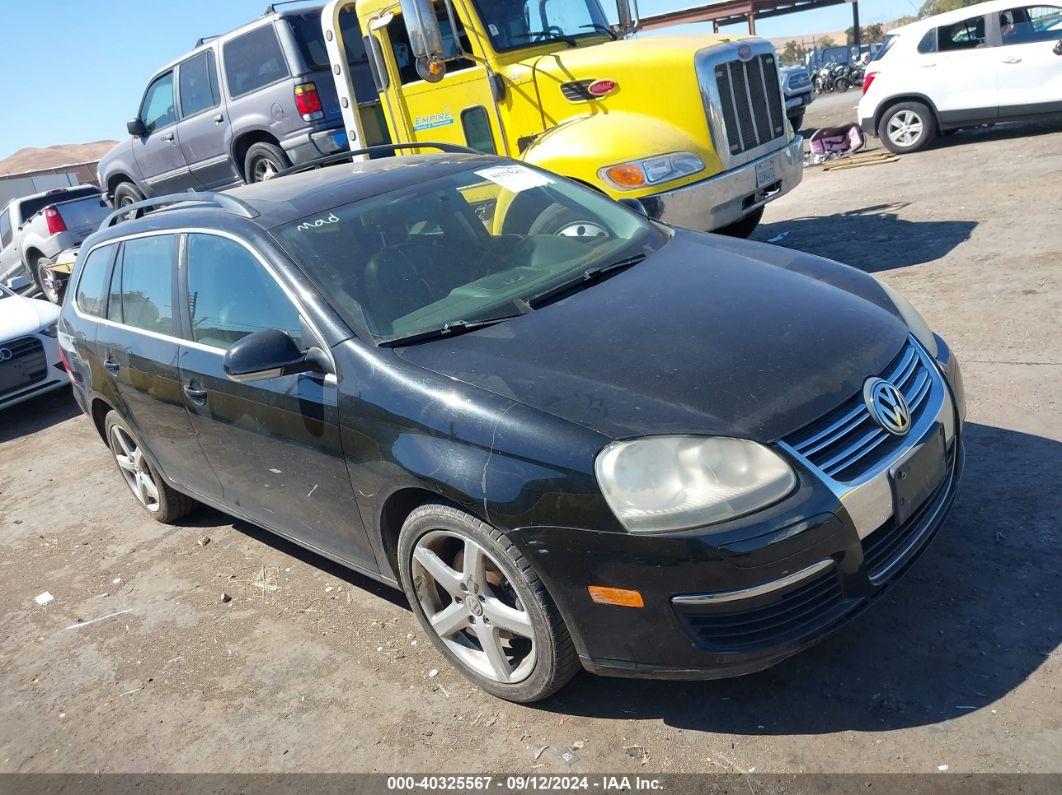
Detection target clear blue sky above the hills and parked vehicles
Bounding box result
[0,0,920,158]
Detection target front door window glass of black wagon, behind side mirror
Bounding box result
[187,235,303,349]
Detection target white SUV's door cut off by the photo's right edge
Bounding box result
[998,3,1062,118]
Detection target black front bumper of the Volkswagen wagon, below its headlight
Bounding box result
[511,343,964,679]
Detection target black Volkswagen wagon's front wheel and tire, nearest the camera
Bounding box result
[398,504,581,704]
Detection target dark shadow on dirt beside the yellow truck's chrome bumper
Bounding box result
[753,204,977,273]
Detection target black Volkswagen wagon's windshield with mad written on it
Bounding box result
[273,163,668,343]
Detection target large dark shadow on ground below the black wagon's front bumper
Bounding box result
[541,425,1062,734]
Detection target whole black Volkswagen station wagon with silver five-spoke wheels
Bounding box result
[59,152,964,702]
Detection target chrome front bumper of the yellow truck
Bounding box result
[641,136,804,231]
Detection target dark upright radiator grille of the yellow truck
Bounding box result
[715,53,786,156]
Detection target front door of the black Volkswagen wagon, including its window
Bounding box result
[172,234,377,570]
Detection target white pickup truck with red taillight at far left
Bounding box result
[0,185,110,304]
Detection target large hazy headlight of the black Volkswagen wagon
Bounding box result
[595,436,797,533]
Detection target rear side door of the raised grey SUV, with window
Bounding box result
[177,49,240,190]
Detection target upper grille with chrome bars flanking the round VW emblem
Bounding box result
[784,339,939,483]
